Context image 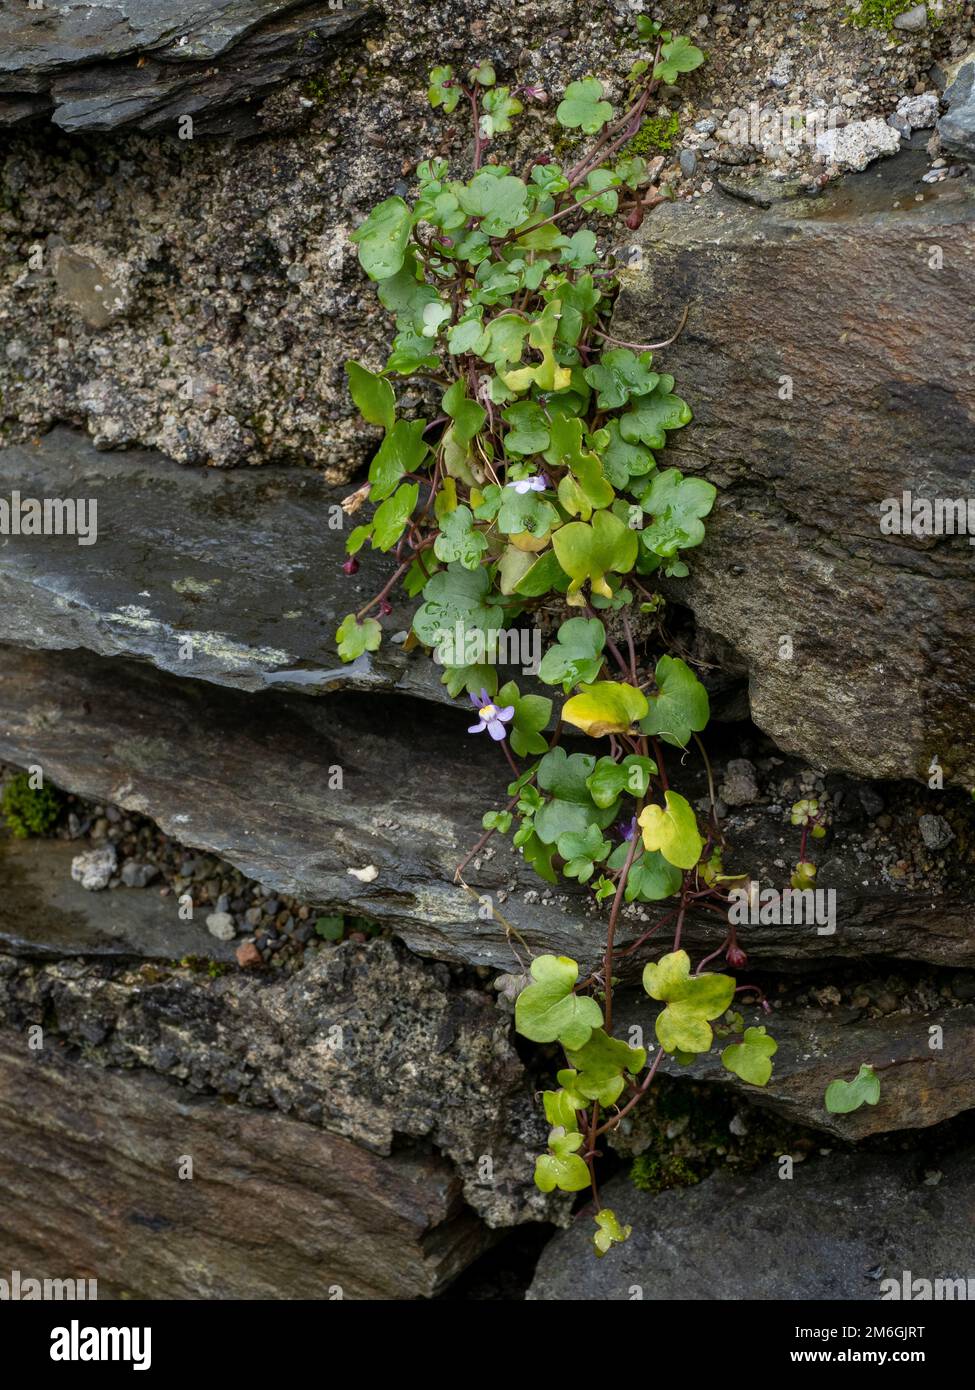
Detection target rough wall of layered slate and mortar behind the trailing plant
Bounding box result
[0,0,975,1300]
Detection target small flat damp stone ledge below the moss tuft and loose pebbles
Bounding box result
[0,840,232,960]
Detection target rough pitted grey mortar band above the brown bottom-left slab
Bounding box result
[0,940,558,1226]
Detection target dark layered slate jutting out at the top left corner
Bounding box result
[0,0,369,135]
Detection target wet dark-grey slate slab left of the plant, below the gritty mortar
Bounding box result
[0,430,449,701]
